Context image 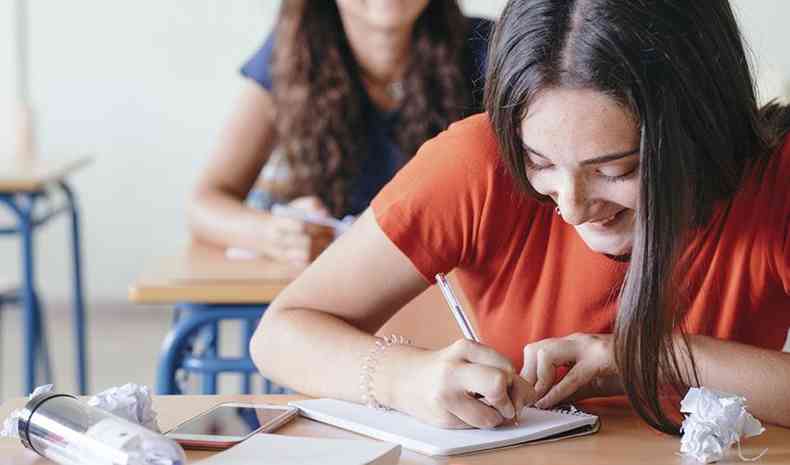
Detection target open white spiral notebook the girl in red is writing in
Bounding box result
[290,399,599,455]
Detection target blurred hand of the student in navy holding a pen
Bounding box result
[260,196,335,264]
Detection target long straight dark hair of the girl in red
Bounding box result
[485,0,790,434]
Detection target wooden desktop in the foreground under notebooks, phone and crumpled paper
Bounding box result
[0,396,790,465]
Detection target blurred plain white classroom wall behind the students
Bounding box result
[0,0,790,301]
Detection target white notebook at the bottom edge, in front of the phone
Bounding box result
[194,434,400,465]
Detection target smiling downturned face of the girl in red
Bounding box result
[521,89,639,255]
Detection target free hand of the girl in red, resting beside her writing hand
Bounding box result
[521,333,622,408]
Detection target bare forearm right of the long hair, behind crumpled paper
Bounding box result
[686,335,790,427]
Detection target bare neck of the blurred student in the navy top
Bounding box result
[342,17,412,83]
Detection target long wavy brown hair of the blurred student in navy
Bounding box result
[273,0,479,215]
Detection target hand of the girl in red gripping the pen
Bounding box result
[403,339,535,428]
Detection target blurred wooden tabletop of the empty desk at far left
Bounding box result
[0,157,91,192]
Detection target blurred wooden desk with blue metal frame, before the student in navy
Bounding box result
[129,244,303,394]
